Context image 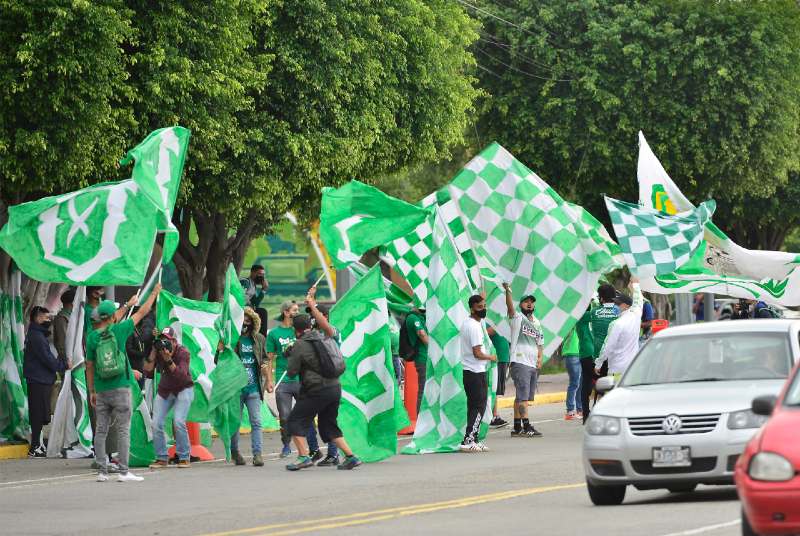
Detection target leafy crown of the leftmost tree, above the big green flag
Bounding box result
[0,1,132,285]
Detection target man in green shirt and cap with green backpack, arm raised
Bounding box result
[86,283,161,482]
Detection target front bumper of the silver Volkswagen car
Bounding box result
[583,426,756,489]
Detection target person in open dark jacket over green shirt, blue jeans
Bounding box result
[231,307,273,467]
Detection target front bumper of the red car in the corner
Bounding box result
[736,469,800,535]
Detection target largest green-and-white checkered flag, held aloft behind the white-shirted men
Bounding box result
[438,143,624,360]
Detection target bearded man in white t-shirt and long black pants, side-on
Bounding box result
[460,295,497,452]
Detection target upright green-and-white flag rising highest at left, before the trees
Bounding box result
[120,127,191,264]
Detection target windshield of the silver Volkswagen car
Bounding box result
[620,332,791,387]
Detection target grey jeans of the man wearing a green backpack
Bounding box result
[94,387,131,474]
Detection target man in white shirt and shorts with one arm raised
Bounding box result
[503,283,544,437]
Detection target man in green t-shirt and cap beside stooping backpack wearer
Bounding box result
[267,301,300,458]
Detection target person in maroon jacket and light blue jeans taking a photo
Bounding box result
[143,328,194,469]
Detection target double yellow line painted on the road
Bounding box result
[206,483,586,536]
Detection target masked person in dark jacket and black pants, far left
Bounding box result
[22,305,70,458]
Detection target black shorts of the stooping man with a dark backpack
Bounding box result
[289,385,342,443]
